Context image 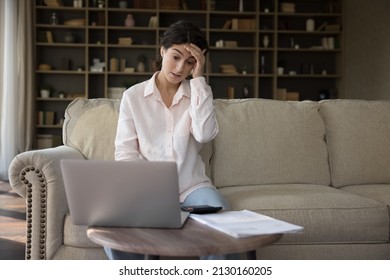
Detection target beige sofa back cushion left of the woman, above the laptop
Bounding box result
[62,98,120,160]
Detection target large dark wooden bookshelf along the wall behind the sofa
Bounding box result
[34,0,343,149]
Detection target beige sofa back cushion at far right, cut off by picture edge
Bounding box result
[320,100,390,187]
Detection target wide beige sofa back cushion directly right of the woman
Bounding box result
[211,99,330,187]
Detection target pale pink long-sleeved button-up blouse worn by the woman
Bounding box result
[115,72,219,201]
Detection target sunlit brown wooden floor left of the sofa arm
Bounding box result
[0,181,26,260]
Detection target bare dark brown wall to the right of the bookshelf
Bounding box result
[343,0,390,100]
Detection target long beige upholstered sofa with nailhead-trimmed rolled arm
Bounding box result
[9,99,390,259]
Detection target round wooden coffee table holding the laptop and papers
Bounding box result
[87,219,283,259]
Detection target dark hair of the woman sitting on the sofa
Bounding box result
[155,20,209,70]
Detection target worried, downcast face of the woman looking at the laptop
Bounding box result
[160,44,196,84]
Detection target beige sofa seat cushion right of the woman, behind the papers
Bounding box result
[219,184,389,244]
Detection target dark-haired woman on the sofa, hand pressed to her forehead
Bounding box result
[105,21,233,259]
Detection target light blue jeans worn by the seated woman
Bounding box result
[104,187,239,260]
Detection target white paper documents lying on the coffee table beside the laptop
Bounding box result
[190,210,303,238]
